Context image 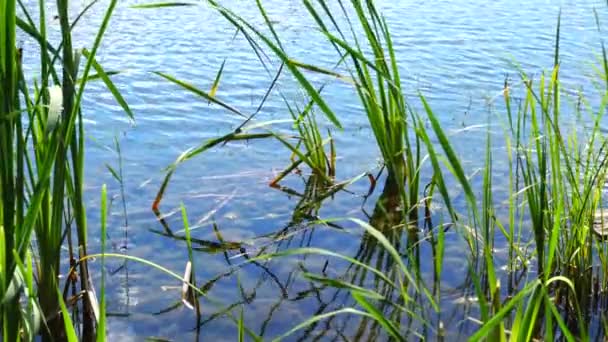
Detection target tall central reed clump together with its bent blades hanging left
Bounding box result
[204,0,422,223]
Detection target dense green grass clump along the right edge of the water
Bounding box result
[419,13,608,340]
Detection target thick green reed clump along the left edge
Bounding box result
[0,0,132,341]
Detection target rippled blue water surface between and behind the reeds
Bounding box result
[19,0,608,341]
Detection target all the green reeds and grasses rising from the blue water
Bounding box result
[0,0,608,341]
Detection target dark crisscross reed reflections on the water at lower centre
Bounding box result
[150,165,471,340]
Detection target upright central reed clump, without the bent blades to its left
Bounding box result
[304,0,421,219]
